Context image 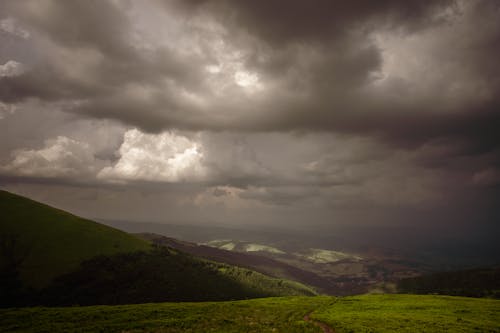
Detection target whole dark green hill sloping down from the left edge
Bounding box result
[0,191,316,307]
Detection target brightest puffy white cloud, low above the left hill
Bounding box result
[98,129,207,182]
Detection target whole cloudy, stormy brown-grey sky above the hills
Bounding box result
[0,0,500,244]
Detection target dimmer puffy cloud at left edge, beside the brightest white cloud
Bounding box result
[1,136,98,177]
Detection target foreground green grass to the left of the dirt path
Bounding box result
[0,297,334,333]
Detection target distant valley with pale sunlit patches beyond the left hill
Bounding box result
[141,234,430,296]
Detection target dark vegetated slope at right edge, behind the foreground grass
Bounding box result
[398,267,500,298]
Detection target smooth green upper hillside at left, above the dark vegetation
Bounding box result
[0,191,150,288]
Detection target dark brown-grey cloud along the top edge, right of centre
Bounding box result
[171,0,452,46]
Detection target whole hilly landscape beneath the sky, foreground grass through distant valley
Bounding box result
[0,191,500,333]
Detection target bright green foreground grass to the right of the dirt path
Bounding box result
[311,295,500,333]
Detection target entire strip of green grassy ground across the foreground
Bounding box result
[0,295,500,333]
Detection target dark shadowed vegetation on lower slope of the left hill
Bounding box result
[40,247,315,305]
